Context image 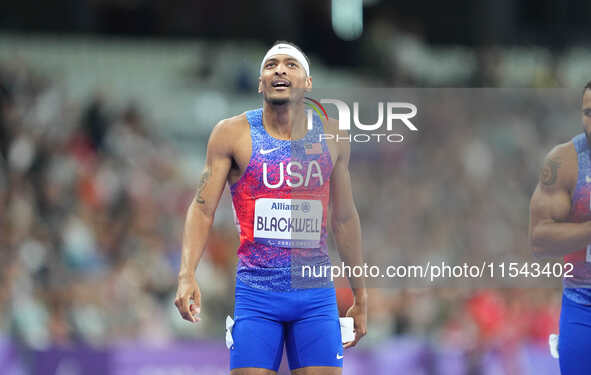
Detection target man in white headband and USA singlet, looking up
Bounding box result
[175,42,367,375]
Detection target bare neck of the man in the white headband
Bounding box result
[263,102,307,139]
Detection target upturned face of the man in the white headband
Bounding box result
[259,55,312,104]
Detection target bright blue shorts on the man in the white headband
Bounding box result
[230,279,344,371]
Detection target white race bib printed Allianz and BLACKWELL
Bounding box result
[254,198,322,248]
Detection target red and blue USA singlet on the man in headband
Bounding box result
[230,108,332,291]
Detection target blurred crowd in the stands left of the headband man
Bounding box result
[0,58,240,348]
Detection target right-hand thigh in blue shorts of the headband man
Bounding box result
[285,288,344,374]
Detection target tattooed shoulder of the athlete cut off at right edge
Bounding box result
[540,142,578,191]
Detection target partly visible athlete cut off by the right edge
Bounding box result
[529,81,591,375]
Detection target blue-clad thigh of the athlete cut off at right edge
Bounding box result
[558,297,591,375]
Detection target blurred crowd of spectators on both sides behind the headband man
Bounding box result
[0,45,576,374]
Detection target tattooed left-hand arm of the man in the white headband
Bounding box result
[175,122,232,322]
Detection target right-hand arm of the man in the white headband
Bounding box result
[330,128,367,348]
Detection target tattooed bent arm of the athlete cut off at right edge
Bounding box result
[529,143,591,257]
